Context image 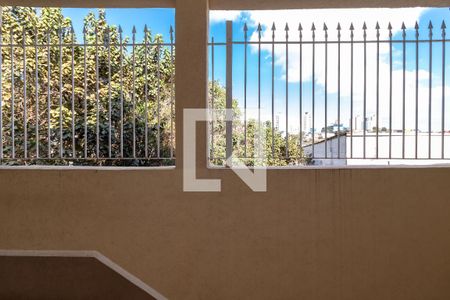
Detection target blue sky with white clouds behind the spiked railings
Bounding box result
[60,8,450,132]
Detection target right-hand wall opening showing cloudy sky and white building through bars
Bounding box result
[209,8,450,166]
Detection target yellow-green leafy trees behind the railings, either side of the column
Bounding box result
[1,7,305,166]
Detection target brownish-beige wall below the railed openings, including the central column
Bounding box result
[0,0,450,300]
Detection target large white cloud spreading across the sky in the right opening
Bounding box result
[211,8,449,130]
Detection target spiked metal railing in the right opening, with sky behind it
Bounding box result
[209,21,450,165]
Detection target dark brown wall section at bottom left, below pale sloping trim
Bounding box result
[0,254,157,300]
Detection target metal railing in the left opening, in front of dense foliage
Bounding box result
[0,14,175,166]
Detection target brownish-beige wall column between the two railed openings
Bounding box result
[175,0,209,176]
